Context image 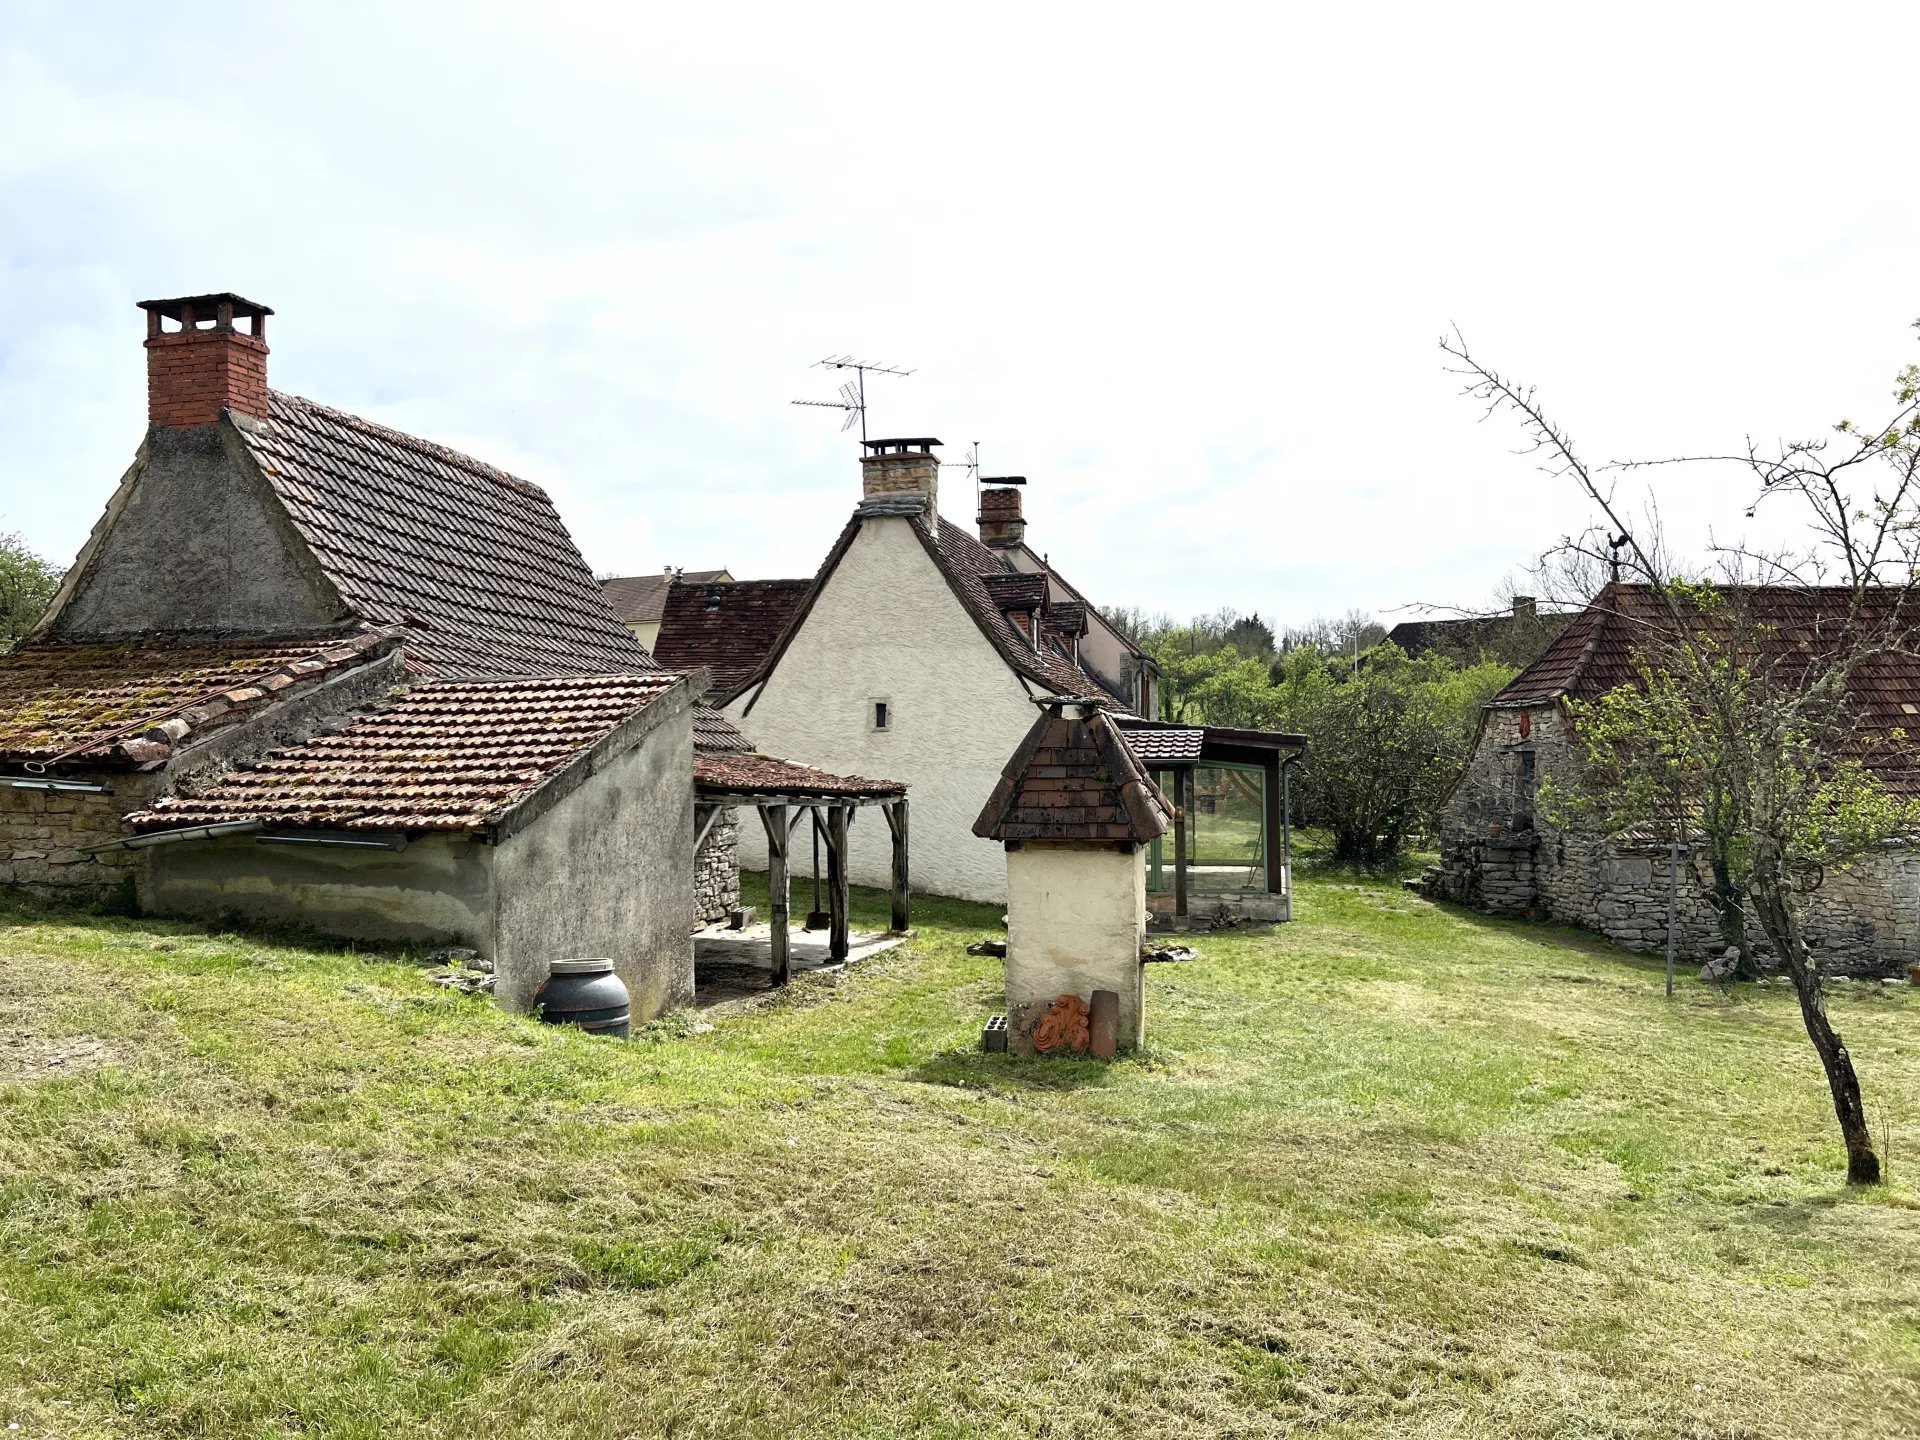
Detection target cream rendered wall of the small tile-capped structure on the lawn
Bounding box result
[1006,841,1146,1054]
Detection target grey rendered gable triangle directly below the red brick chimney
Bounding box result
[48,422,348,636]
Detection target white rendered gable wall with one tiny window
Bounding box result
[726,518,1039,904]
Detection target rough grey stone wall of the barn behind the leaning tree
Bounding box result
[1425,707,1920,975]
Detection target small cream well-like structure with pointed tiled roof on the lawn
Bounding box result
[973,697,1173,1054]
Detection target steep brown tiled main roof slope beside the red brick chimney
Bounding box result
[238,392,659,676]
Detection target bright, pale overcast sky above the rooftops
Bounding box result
[0,0,1920,622]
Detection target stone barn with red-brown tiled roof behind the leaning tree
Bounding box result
[1423,584,1920,973]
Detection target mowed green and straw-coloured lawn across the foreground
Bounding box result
[0,881,1920,1438]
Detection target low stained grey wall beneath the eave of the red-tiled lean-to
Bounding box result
[140,835,497,954]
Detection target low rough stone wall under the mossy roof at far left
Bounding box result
[0,772,161,900]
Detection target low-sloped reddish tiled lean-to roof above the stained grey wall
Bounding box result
[129,672,682,831]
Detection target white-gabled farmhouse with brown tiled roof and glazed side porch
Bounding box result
[714,440,1304,920]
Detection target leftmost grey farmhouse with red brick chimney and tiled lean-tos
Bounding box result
[0,294,883,1018]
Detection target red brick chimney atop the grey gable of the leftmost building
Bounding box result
[140,294,273,428]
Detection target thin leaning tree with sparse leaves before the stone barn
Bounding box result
[1440,330,1920,1185]
